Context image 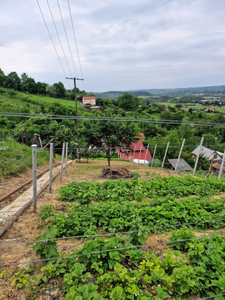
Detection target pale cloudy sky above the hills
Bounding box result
[0,0,225,92]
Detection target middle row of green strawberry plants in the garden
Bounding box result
[39,196,225,244]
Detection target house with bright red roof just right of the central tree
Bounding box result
[117,133,152,164]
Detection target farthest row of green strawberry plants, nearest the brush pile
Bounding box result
[56,176,225,204]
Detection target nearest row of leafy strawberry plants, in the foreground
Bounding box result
[4,228,225,300]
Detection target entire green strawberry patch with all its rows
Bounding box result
[0,176,225,300]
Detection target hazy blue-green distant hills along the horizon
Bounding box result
[92,85,225,99]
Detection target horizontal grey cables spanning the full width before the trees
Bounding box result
[0,112,225,127]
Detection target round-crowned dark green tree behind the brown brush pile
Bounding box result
[82,113,138,166]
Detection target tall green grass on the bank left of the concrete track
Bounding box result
[0,139,49,182]
